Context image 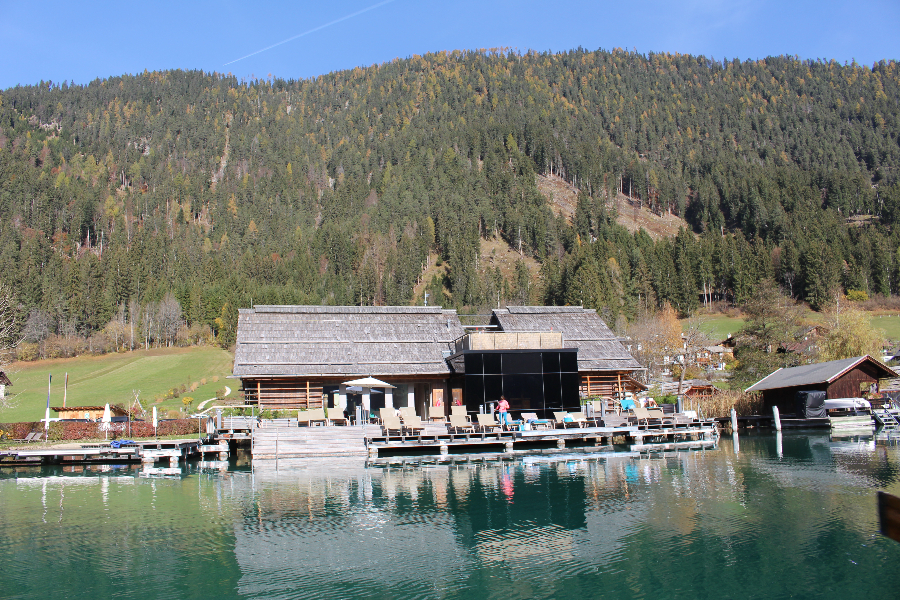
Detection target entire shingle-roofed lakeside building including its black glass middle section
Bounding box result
[233,306,644,416]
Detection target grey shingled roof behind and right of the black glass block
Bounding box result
[493,306,643,371]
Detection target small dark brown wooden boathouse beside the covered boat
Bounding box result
[746,356,896,414]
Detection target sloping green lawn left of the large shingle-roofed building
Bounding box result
[0,348,240,423]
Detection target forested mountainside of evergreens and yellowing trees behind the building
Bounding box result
[0,49,900,352]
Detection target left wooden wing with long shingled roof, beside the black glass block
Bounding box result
[234,306,465,414]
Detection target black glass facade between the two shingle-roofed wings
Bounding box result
[462,349,580,416]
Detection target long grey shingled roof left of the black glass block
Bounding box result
[234,306,464,377]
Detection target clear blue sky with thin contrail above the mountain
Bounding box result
[0,0,900,89]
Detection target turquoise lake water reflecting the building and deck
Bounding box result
[0,433,900,600]
